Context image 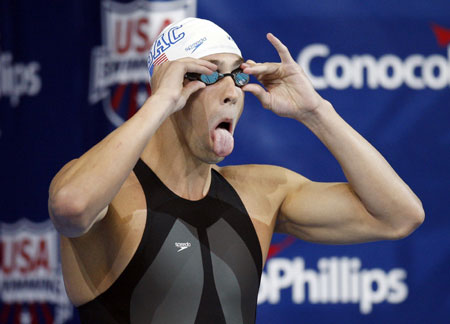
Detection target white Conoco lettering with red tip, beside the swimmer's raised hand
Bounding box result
[297,25,450,90]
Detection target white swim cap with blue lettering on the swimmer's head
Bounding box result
[147,18,242,79]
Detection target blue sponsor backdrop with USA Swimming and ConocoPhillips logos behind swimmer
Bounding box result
[0,0,450,324]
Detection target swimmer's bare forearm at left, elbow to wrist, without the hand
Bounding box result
[48,96,170,237]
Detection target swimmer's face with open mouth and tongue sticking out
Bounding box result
[174,54,244,163]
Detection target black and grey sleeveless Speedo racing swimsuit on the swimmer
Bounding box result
[78,160,262,324]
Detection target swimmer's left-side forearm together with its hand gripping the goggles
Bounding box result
[48,59,217,237]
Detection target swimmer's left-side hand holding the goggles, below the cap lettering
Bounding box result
[151,58,217,113]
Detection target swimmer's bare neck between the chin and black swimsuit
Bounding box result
[141,118,212,200]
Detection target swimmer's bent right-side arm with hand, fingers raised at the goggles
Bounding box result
[242,34,424,243]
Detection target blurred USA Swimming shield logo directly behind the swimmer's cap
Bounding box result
[89,0,196,126]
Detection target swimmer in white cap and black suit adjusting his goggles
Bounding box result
[49,18,424,324]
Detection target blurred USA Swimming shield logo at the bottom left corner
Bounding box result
[0,218,73,324]
